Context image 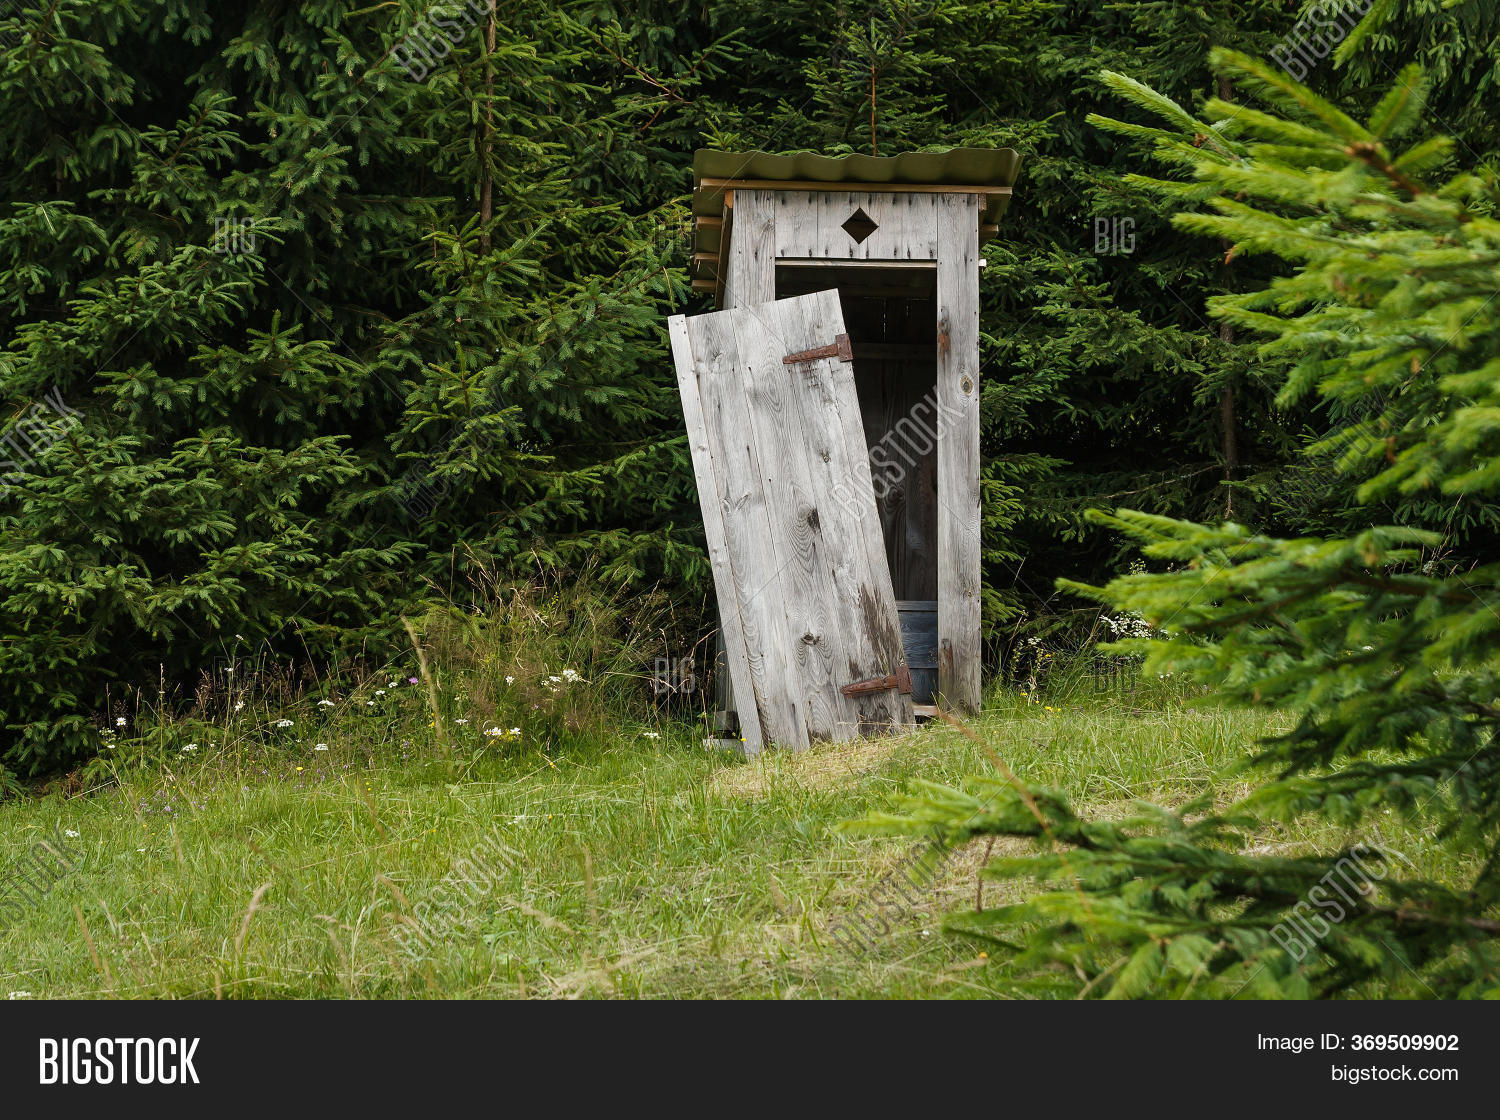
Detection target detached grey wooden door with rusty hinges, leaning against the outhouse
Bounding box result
[669,291,914,753]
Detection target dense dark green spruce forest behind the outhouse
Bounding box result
[0,0,1500,772]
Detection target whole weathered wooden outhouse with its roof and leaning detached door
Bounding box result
[671,148,1020,753]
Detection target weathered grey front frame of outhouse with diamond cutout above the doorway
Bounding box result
[722,187,984,711]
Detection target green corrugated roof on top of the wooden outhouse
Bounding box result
[693,148,1022,293]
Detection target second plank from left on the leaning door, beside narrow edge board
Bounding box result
[687,310,807,750]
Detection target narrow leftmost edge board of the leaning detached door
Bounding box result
[668,315,765,754]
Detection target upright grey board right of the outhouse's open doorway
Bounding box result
[938,195,980,712]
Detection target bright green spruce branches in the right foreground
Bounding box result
[870,51,1500,999]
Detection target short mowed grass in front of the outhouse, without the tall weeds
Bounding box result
[0,690,1452,999]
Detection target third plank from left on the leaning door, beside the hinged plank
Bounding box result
[735,300,848,739]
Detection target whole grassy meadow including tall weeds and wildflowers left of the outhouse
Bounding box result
[0,595,1452,999]
